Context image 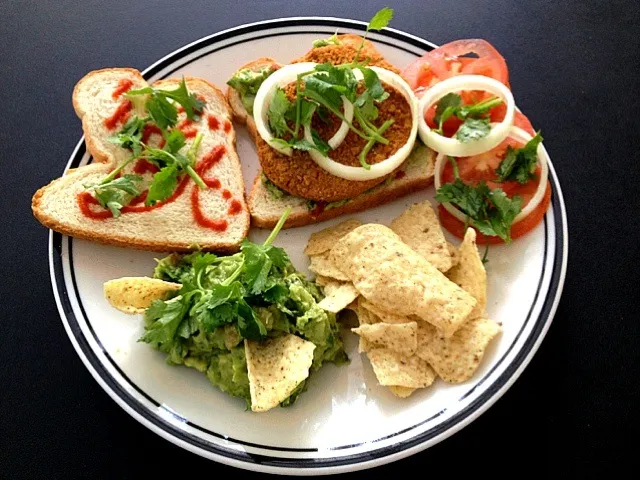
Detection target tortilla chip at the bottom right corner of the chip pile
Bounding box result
[417,318,501,383]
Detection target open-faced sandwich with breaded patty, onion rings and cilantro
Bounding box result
[227,9,434,227]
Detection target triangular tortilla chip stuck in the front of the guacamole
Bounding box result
[244,333,316,412]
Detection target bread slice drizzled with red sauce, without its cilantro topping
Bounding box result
[32,68,250,255]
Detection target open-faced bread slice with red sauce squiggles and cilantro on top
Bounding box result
[32,68,249,251]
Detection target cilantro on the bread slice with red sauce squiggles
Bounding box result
[86,78,207,217]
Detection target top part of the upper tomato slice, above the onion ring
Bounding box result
[402,39,509,93]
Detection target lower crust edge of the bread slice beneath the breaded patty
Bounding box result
[248,141,435,228]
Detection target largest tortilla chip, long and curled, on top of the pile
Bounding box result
[329,224,476,337]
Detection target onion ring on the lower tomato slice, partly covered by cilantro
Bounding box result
[433,126,549,224]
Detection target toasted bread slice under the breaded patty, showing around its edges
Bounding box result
[227,34,434,228]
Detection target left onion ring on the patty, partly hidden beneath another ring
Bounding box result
[253,62,353,157]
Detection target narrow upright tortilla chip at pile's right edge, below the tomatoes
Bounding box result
[447,228,487,318]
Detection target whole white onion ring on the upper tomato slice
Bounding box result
[418,75,516,157]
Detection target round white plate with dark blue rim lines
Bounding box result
[50,18,567,474]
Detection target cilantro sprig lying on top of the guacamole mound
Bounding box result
[140,208,294,348]
